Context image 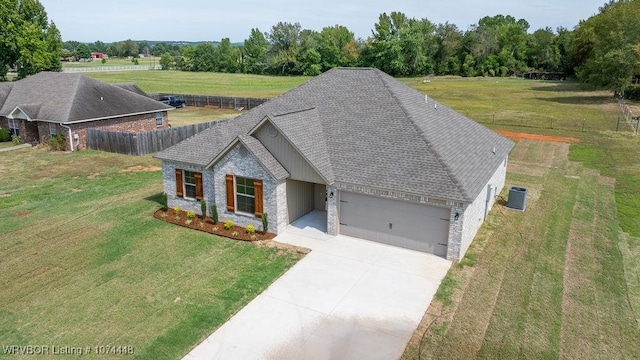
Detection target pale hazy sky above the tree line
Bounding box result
[40,0,607,42]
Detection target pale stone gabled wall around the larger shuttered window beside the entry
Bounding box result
[213,144,280,233]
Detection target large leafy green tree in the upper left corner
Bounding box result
[0,0,62,80]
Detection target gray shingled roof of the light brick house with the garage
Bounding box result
[157,68,513,202]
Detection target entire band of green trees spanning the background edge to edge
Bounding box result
[0,0,640,93]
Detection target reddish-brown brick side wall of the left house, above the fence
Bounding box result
[66,111,169,150]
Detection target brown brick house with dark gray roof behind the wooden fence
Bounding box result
[0,72,173,151]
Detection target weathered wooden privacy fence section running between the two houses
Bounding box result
[87,120,228,155]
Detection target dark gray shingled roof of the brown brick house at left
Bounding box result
[0,72,173,123]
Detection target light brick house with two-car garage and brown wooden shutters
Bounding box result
[156,68,513,260]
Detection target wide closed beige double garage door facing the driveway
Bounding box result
[340,192,451,257]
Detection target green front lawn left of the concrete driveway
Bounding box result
[0,149,300,359]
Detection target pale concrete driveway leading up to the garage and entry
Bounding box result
[184,221,451,360]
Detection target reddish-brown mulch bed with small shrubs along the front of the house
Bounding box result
[153,209,276,241]
